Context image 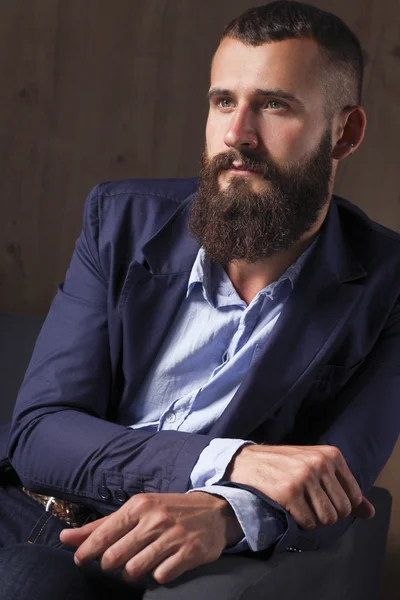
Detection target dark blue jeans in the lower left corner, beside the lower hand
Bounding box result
[0,485,145,600]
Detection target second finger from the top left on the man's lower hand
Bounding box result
[75,510,138,565]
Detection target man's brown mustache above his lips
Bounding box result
[202,150,278,179]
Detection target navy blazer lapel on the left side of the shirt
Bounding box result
[118,194,198,423]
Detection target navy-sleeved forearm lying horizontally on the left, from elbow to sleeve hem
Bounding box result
[9,409,210,514]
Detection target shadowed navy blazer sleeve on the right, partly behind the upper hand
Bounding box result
[233,302,400,552]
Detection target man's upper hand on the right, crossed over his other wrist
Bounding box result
[224,445,375,529]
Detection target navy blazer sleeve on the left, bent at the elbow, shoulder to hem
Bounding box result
[7,187,211,514]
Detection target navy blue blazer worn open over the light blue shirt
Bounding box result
[0,179,400,551]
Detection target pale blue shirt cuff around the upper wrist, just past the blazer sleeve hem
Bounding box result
[190,438,254,488]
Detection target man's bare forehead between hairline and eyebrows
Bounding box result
[211,38,321,93]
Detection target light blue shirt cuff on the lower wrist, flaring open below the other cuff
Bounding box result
[187,485,286,553]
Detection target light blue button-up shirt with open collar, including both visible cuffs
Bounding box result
[131,240,316,552]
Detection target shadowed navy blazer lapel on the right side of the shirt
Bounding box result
[210,199,366,437]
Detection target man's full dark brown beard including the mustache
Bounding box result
[188,129,332,265]
